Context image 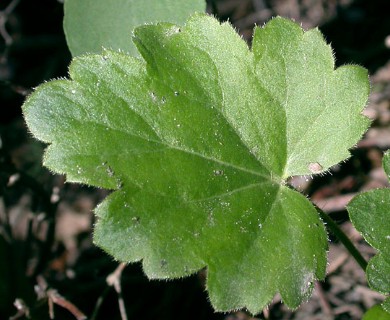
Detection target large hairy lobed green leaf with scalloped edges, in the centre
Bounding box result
[23,14,369,313]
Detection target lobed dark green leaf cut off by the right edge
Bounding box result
[348,152,390,312]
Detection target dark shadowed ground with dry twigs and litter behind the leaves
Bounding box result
[0,0,390,320]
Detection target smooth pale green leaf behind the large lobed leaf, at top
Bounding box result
[64,0,206,56]
